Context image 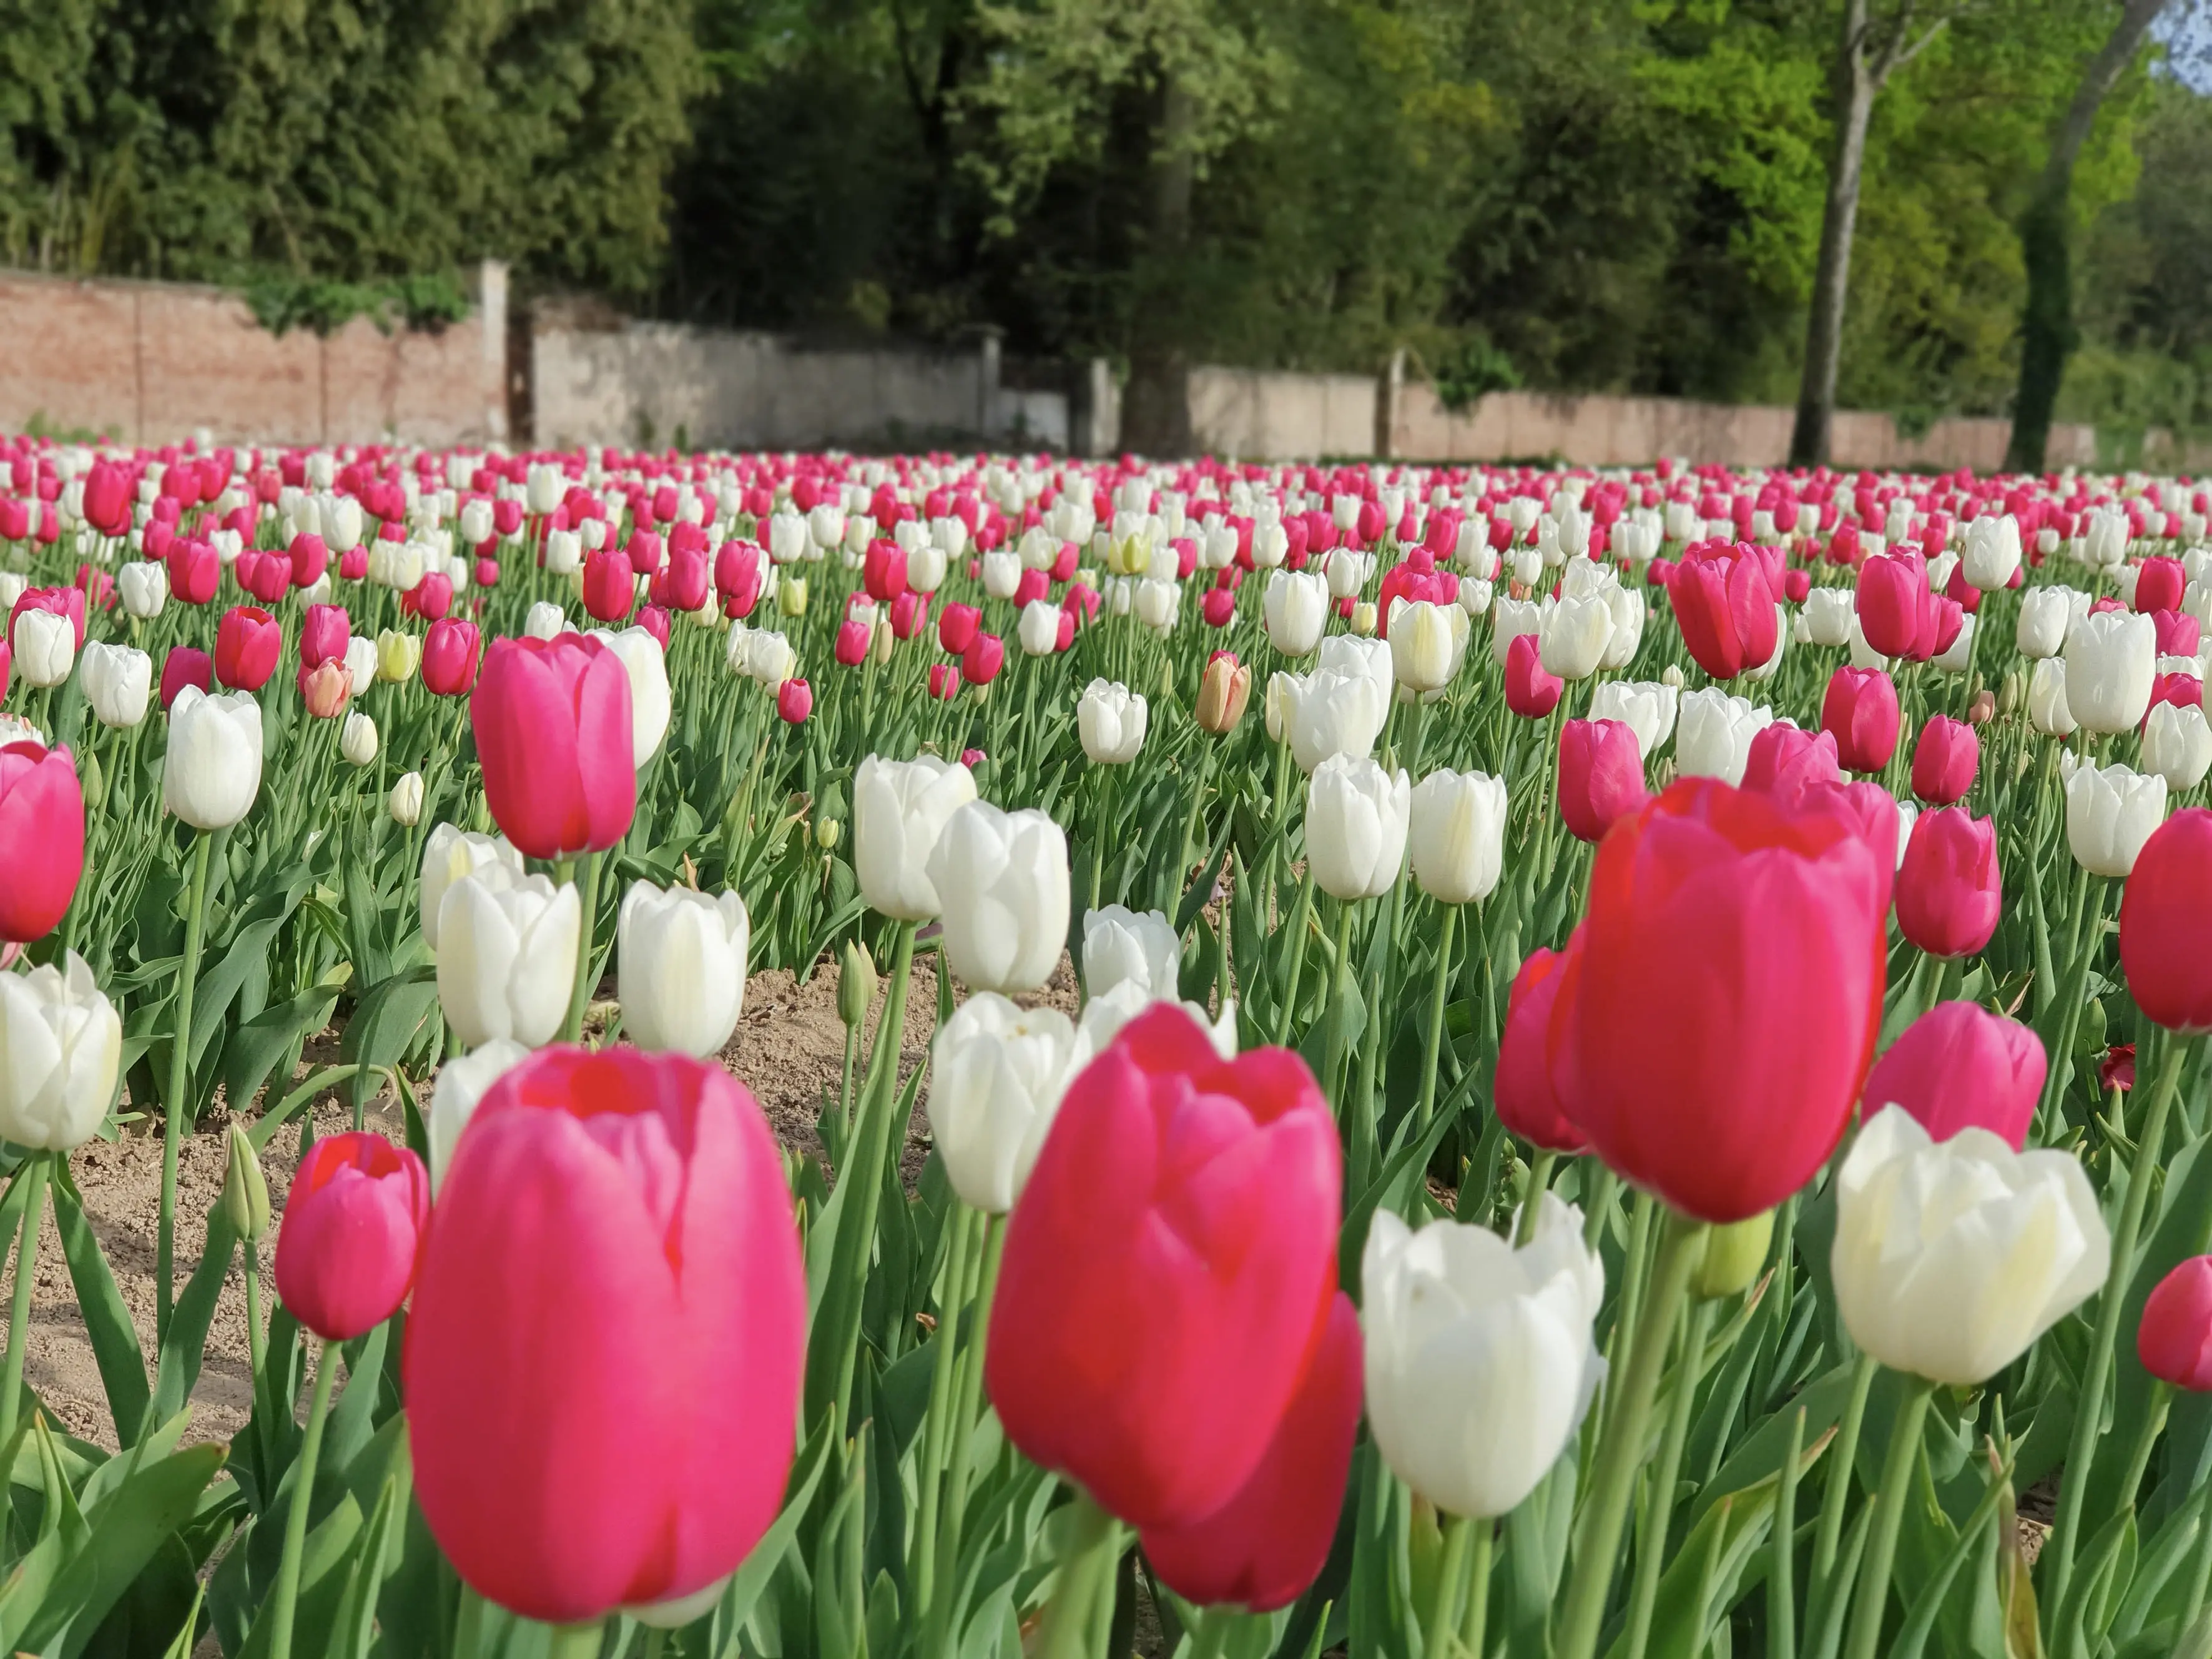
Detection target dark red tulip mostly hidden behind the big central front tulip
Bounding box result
[1137,1292,1362,1613]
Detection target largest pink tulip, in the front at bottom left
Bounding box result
[405,1053,807,1623]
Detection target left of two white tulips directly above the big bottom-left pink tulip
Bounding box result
[438,863,582,1048]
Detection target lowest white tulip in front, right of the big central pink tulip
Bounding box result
[1360,1192,1606,1520]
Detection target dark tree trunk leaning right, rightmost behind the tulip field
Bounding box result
[2004,0,2166,473]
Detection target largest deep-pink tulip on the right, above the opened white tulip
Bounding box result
[1546,779,1889,1221]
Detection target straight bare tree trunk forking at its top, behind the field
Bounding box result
[1789,0,1958,467]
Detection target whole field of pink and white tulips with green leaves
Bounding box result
[0,438,2212,1659]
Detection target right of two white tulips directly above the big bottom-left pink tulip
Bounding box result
[615,880,752,1060]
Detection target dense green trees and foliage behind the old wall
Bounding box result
[0,0,2212,449]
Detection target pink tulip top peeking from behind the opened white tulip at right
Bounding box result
[1862,1002,2048,1153]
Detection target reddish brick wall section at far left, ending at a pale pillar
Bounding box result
[0,265,506,445]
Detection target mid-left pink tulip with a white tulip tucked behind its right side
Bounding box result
[469,633,637,859]
